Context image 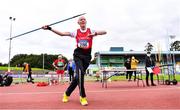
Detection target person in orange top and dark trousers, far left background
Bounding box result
[23,62,34,83]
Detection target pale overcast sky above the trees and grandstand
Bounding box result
[0,0,180,63]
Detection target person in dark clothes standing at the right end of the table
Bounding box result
[145,52,156,86]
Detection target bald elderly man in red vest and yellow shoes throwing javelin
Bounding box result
[42,16,106,105]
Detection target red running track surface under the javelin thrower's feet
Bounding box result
[0,81,180,110]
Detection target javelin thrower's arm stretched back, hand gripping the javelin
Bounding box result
[42,25,71,36]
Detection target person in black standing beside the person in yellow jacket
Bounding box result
[124,58,132,81]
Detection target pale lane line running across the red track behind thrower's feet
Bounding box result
[0,87,180,96]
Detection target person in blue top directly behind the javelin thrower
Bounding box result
[67,59,76,82]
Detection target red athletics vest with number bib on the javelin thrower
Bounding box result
[76,28,93,49]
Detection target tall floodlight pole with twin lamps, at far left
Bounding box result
[8,17,16,72]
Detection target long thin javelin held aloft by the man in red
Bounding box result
[6,13,86,40]
